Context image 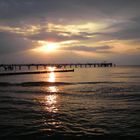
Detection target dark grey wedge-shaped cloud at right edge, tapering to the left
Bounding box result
[89,17,140,40]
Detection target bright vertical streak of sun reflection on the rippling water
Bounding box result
[35,68,61,130]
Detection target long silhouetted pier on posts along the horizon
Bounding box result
[0,62,116,71]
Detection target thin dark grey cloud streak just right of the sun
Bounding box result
[60,46,113,53]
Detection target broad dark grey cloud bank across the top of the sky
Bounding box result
[0,0,140,20]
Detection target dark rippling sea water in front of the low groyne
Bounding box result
[0,67,140,140]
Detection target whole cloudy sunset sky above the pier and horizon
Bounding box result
[0,0,140,65]
